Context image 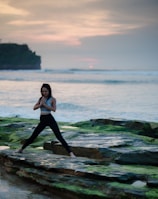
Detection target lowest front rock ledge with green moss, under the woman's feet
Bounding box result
[0,150,158,199]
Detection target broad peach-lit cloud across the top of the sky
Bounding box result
[1,0,157,45]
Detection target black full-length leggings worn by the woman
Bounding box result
[22,114,71,153]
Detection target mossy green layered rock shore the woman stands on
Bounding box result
[0,118,158,199]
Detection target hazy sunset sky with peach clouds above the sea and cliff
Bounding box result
[0,0,158,70]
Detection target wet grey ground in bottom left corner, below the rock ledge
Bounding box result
[0,167,61,199]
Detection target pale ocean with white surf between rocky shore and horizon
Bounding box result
[0,69,158,123]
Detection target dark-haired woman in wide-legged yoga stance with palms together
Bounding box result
[18,84,75,157]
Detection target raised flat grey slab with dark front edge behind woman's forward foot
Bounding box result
[44,126,158,166]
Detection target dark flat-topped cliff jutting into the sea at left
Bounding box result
[0,43,41,70]
